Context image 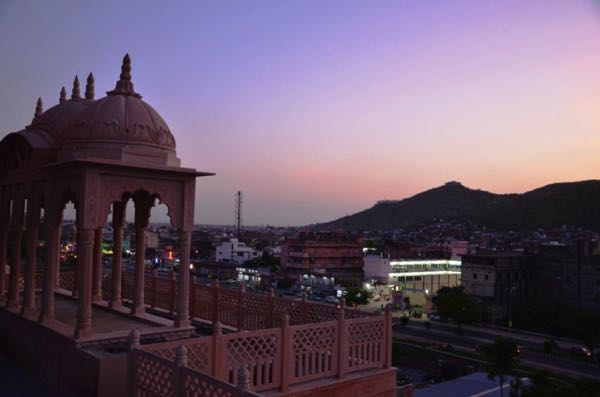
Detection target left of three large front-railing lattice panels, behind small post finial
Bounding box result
[223,329,281,391]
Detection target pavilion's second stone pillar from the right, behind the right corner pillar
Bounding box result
[131,199,150,314]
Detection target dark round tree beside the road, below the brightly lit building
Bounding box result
[432,287,480,335]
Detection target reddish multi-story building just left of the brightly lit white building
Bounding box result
[281,232,364,287]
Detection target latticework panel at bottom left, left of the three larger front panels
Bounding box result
[134,351,175,397]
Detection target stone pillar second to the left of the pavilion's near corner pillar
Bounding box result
[21,198,40,316]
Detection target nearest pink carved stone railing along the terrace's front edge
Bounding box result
[139,309,391,392]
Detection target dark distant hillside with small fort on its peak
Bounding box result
[314,180,600,230]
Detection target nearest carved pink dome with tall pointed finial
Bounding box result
[61,54,175,152]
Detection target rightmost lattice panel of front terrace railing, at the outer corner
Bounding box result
[347,317,386,371]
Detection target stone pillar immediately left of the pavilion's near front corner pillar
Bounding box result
[40,210,62,323]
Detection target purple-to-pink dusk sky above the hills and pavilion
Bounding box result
[0,0,600,226]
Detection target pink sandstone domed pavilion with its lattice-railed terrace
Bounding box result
[0,55,396,397]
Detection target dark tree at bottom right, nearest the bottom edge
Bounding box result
[479,336,517,397]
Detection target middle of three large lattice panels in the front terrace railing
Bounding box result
[292,322,338,382]
